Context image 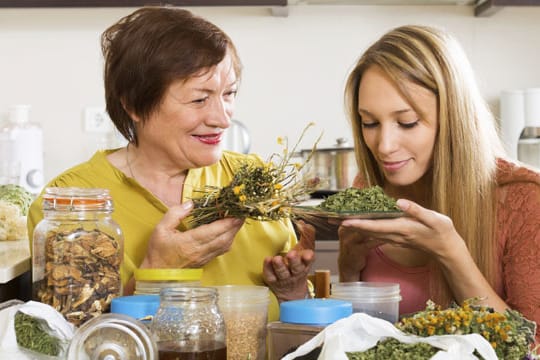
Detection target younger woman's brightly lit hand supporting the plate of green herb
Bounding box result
[341,199,463,259]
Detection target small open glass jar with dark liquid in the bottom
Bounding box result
[151,287,227,360]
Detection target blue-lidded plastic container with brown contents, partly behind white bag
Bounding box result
[267,299,352,360]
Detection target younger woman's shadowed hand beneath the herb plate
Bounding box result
[338,226,382,282]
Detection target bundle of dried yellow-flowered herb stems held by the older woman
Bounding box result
[191,123,321,227]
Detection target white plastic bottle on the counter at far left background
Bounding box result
[0,105,44,194]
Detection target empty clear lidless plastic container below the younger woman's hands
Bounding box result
[330,281,401,323]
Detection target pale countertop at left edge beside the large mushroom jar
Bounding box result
[0,239,31,284]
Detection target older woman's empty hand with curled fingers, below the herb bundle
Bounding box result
[263,220,315,302]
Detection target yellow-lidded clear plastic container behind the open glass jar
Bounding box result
[134,269,203,296]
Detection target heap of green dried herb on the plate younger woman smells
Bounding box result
[318,185,401,213]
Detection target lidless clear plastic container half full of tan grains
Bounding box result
[216,285,270,360]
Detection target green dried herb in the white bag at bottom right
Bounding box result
[346,338,439,360]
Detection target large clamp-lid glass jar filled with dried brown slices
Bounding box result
[32,188,123,326]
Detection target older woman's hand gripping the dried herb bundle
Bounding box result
[140,201,244,268]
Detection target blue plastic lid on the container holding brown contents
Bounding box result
[279,299,352,325]
